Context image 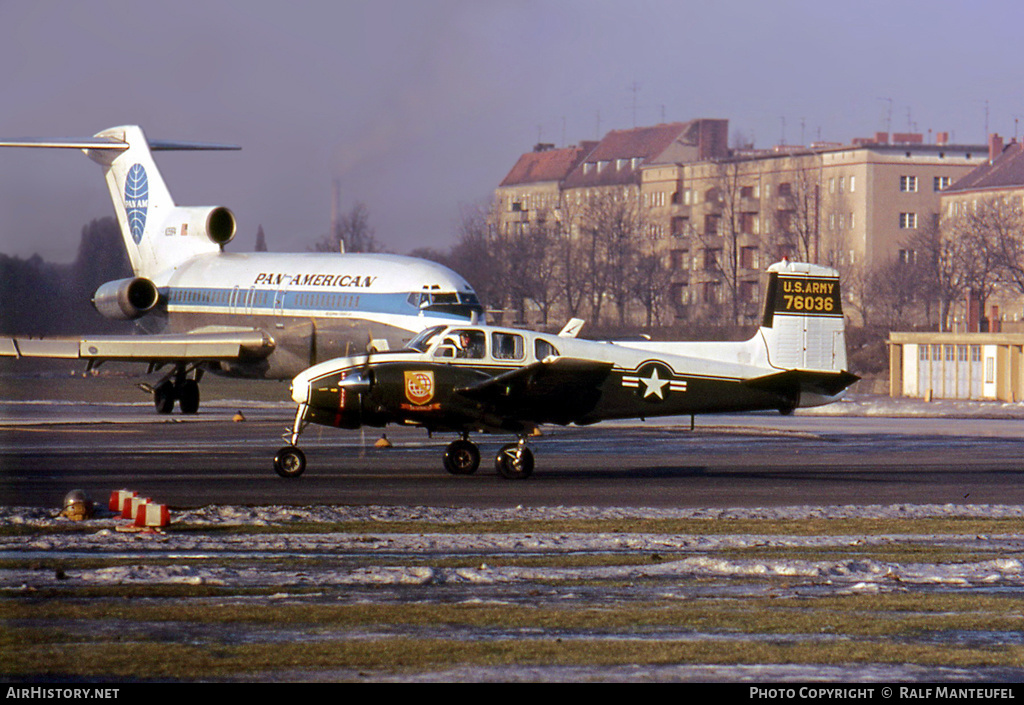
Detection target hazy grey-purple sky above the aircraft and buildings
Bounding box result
[0,0,1024,261]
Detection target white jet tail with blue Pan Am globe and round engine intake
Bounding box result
[0,125,239,279]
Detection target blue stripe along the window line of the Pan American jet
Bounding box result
[160,287,469,321]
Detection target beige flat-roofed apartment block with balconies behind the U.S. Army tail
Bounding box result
[644,134,987,322]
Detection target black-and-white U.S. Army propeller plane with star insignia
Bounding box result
[274,261,858,480]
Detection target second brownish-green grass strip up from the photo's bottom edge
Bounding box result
[0,594,1024,636]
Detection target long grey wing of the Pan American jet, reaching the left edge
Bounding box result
[0,330,274,363]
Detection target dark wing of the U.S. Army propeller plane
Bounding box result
[455,358,612,423]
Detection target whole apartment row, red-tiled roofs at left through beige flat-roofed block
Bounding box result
[493,119,988,323]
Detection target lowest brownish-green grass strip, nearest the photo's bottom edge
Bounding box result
[0,638,1024,679]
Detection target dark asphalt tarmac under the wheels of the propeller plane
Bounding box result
[0,401,1024,507]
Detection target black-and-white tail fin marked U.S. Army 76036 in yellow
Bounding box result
[760,261,847,372]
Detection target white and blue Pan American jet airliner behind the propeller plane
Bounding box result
[0,125,483,413]
